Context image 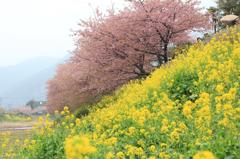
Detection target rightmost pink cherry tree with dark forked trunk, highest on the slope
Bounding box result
[128,0,210,62]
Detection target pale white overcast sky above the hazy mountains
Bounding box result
[0,0,215,67]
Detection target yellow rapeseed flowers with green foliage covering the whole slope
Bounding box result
[2,27,240,159]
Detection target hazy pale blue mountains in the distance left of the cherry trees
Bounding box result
[0,57,63,108]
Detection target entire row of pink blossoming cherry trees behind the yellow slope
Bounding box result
[48,0,209,110]
